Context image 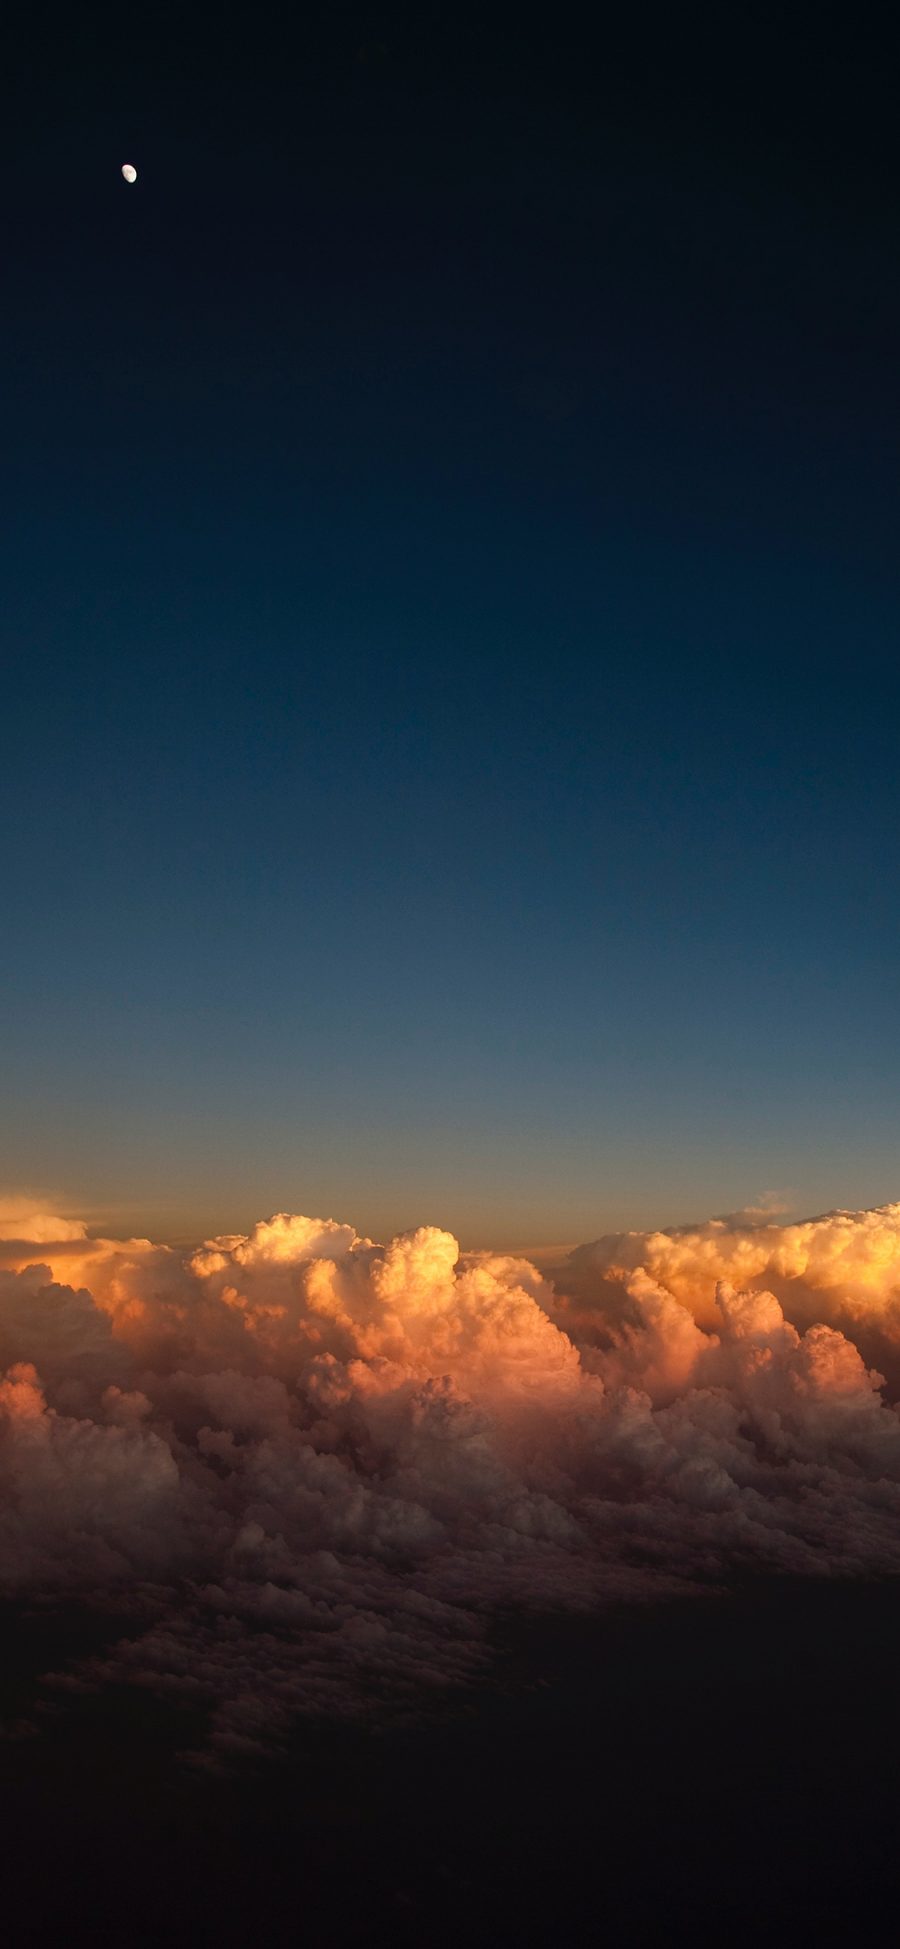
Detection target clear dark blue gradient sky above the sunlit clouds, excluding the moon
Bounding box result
[0,8,900,1245]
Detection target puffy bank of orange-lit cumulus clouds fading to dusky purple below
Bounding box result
[0,1206,900,1756]
